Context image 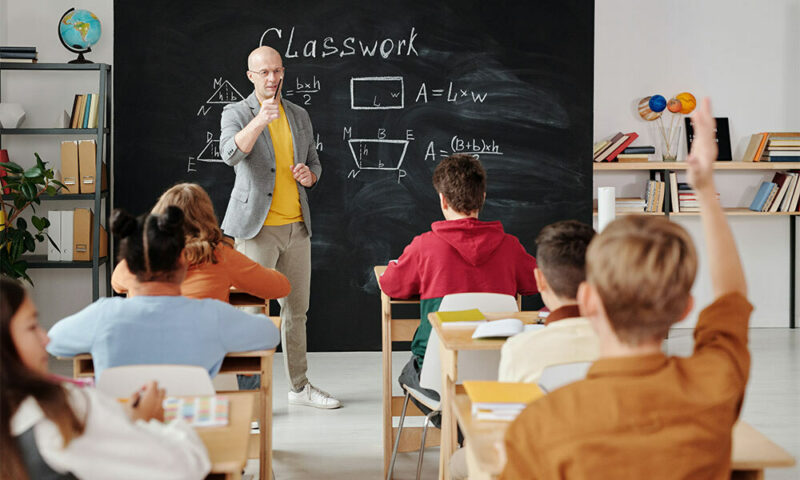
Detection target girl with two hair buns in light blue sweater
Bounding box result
[47,206,280,378]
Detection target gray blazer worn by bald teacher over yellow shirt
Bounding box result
[219,92,322,239]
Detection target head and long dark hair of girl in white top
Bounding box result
[0,275,85,480]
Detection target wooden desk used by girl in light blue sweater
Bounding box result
[64,349,275,480]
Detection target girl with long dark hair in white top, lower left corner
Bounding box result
[0,276,211,480]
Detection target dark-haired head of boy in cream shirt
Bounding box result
[536,220,594,300]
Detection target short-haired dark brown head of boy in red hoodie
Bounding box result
[433,153,486,214]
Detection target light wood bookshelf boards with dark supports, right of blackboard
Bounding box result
[592,162,800,328]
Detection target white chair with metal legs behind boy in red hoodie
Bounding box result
[386,292,519,480]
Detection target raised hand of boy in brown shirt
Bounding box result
[686,98,718,194]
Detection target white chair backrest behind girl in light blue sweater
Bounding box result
[97,365,214,398]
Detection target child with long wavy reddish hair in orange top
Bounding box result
[111,183,291,302]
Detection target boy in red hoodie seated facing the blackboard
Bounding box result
[380,154,537,404]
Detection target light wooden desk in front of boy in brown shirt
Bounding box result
[448,395,795,480]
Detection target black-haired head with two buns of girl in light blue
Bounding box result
[111,206,186,282]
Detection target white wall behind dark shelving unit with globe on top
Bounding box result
[0,0,114,326]
